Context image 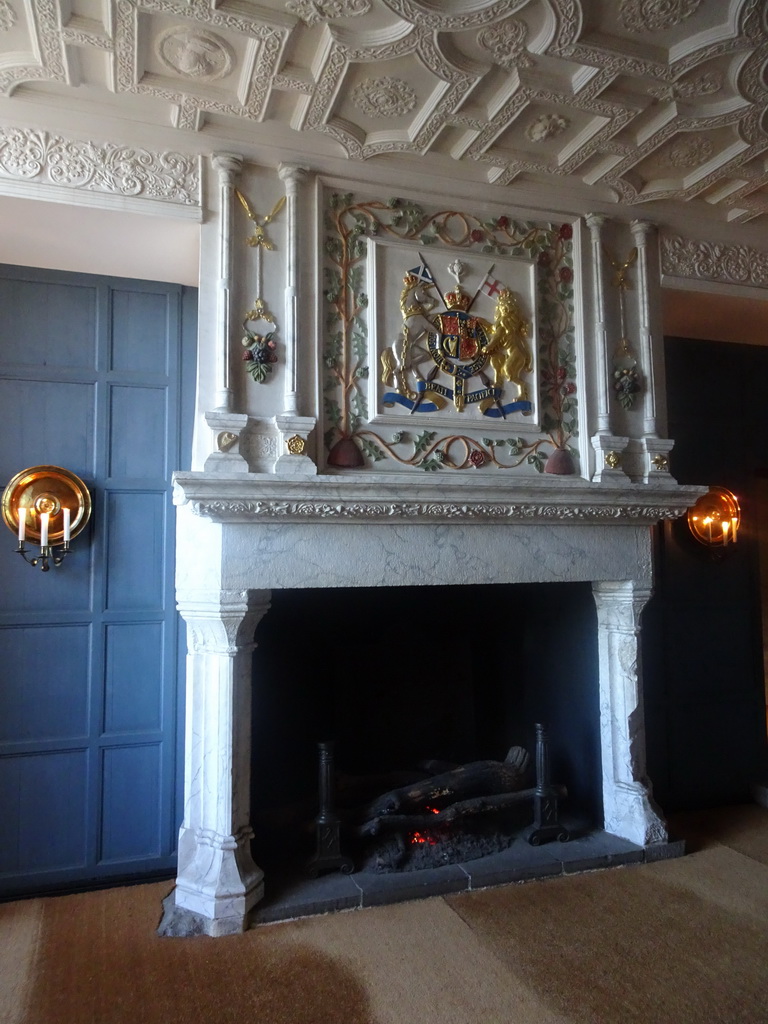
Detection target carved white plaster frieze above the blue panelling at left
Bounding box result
[0,127,202,208]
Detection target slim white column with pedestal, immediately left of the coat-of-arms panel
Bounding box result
[274,164,317,476]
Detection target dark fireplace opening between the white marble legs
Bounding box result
[252,583,602,871]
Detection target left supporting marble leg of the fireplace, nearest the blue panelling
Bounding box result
[160,591,270,935]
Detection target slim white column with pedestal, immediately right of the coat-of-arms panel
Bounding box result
[585,213,629,484]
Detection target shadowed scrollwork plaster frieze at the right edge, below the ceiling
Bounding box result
[660,234,768,288]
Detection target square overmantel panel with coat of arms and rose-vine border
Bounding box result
[323,195,579,472]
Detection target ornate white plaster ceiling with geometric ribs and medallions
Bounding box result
[0,0,768,222]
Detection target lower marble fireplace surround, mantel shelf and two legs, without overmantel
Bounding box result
[166,472,701,935]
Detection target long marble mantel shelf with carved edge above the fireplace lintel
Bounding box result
[174,472,707,525]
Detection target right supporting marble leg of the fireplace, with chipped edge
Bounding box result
[592,581,668,846]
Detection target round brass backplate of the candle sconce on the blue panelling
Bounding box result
[2,466,91,544]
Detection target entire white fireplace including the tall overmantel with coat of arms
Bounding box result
[161,153,716,935]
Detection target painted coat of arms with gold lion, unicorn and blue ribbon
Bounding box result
[381,260,532,419]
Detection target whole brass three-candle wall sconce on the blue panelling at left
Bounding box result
[2,466,91,572]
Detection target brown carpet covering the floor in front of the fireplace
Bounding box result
[0,806,768,1024]
